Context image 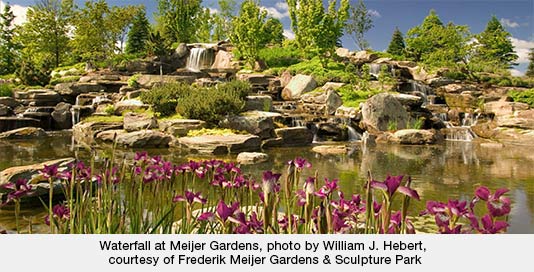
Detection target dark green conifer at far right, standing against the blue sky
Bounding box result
[475,16,519,68]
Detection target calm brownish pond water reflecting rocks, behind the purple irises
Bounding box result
[0,135,534,233]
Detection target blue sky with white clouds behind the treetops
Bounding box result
[3,0,534,73]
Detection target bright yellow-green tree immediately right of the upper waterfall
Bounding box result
[230,0,267,67]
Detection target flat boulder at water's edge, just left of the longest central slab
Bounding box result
[116,130,172,148]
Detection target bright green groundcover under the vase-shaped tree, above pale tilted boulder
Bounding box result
[288,57,356,85]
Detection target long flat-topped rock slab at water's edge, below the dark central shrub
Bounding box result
[177,134,261,155]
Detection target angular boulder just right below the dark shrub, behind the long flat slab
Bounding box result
[219,111,282,139]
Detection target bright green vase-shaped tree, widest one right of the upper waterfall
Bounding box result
[287,0,350,63]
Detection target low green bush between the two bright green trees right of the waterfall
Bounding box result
[259,45,301,68]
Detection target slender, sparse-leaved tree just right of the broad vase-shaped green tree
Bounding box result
[346,0,373,50]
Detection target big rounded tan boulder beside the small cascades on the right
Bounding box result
[362,93,409,131]
